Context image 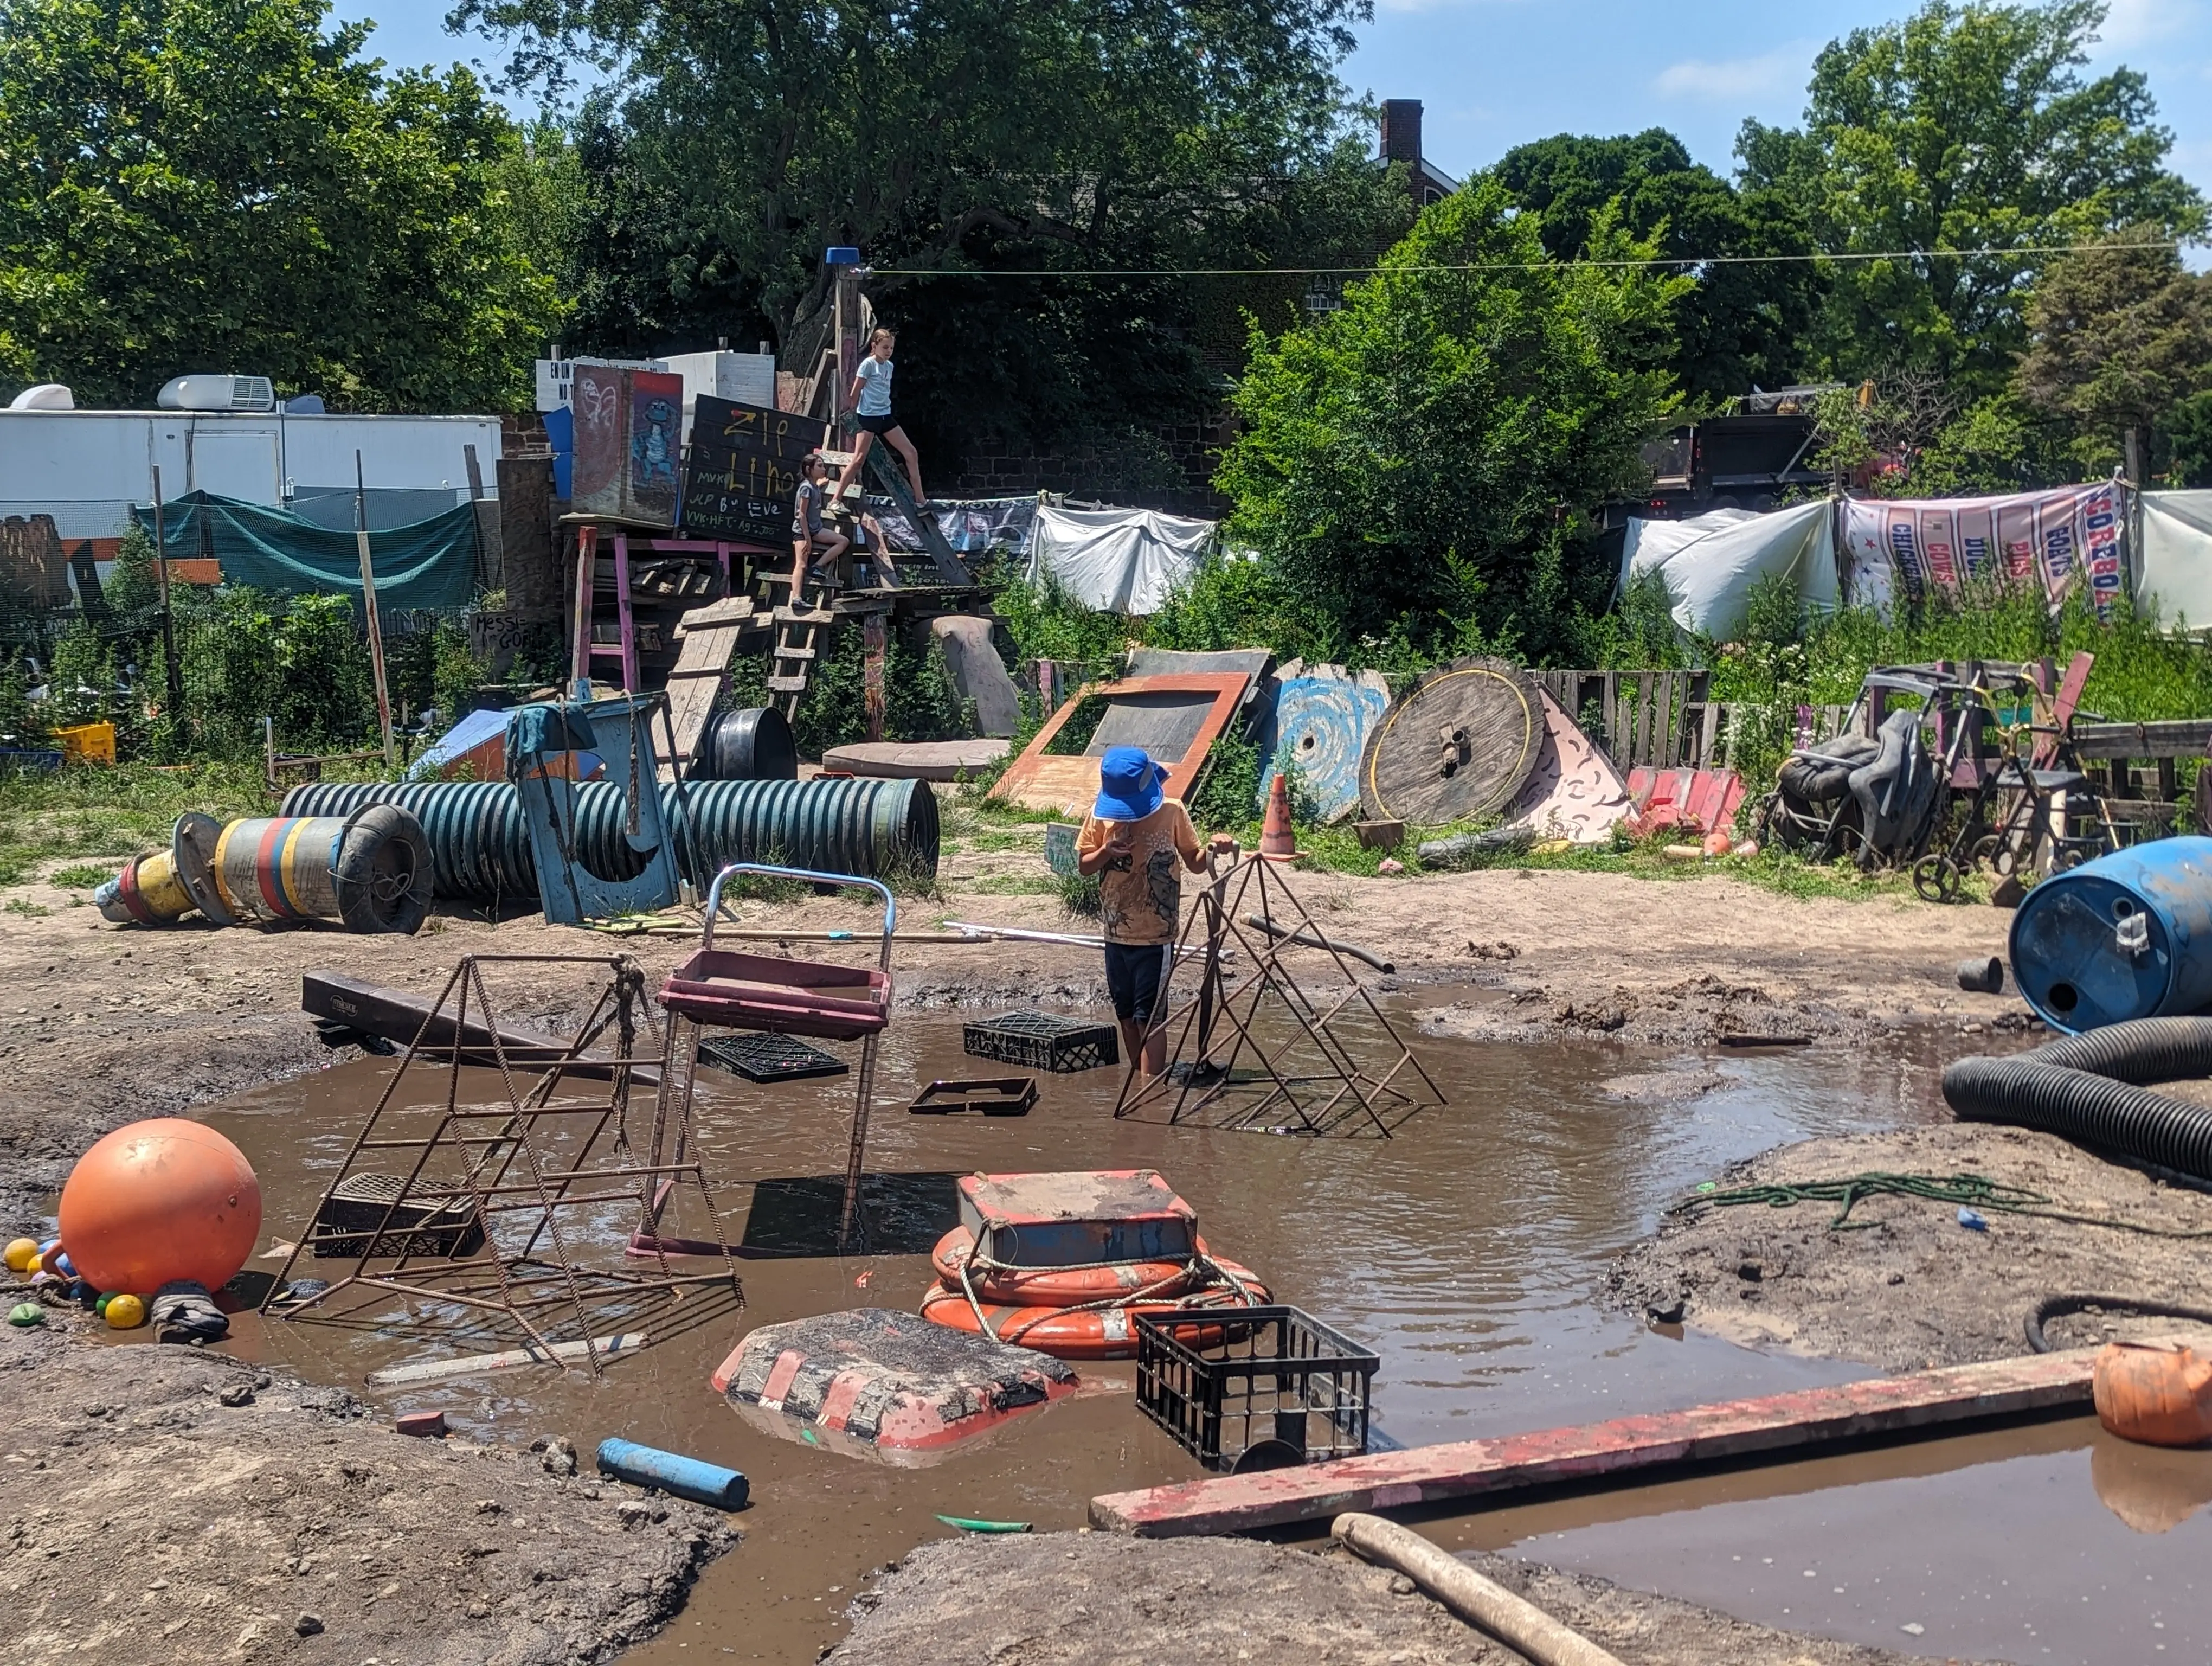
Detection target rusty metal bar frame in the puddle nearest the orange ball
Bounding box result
[261,953,743,1376]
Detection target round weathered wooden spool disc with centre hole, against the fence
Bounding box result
[1360,659,1544,828]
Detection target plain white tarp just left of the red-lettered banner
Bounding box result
[1626,498,1838,642]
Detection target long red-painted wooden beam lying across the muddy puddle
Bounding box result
[1090,1348,2097,1537]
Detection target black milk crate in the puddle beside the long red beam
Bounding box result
[1137,1308,1382,1471]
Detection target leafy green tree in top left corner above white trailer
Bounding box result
[0,0,560,412]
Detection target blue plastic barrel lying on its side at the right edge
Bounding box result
[2011,836,2212,1033]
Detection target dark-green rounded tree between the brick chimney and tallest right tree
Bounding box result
[1495,129,1827,400]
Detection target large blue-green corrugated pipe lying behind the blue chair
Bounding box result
[283,779,938,903]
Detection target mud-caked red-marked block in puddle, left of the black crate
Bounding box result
[715,1308,1075,1451]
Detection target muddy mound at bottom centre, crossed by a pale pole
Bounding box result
[827,1533,1991,1666]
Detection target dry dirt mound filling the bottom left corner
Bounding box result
[0,1310,737,1666]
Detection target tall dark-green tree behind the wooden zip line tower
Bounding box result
[453,0,1409,471]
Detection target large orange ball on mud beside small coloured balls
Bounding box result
[62,1117,261,1290]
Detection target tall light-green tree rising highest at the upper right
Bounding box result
[1737,0,2203,400]
